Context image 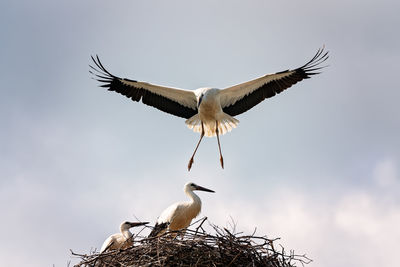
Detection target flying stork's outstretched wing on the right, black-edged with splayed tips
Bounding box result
[220,47,329,116]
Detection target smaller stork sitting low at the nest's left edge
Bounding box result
[100,221,148,253]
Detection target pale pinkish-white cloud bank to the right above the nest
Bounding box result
[204,184,400,267]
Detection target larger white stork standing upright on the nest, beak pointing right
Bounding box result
[149,182,215,237]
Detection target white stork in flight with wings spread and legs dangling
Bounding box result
[90,47,328,171]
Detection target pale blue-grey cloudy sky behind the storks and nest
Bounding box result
[0,0,400,267]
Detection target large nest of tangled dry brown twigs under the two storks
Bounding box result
[71,218,311,267]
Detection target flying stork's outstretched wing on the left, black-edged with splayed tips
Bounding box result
[89,56,197,119]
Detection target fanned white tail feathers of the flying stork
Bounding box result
[185,113,239,137]
